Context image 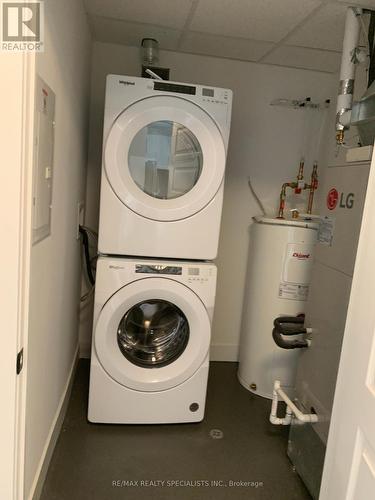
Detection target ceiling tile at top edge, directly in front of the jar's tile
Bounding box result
[84,0,192,29]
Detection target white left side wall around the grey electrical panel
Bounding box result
[25,0,91,498]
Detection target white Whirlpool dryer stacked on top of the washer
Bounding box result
[99,75,232,260]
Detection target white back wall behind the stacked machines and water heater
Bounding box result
[80,42,337,360]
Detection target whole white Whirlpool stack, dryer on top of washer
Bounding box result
[88,75,232,423]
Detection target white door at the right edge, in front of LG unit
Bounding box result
[320,149,375,500]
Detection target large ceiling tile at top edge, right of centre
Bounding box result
[190,0,321,42]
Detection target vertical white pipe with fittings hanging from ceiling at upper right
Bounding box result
[336,7,362,145]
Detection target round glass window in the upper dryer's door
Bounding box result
[128,120,203,200]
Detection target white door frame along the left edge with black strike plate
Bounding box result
[0,47,36,500]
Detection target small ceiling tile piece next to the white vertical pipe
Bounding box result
[285,3,347,51]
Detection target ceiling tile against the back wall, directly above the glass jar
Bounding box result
[89,16,181,50]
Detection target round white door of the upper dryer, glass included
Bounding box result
[104,96,226,221]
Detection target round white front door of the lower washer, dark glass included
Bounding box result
[94,278,211,391]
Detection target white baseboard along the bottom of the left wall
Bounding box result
[28,346,79,500]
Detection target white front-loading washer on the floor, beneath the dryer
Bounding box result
[88,257,216,424]
